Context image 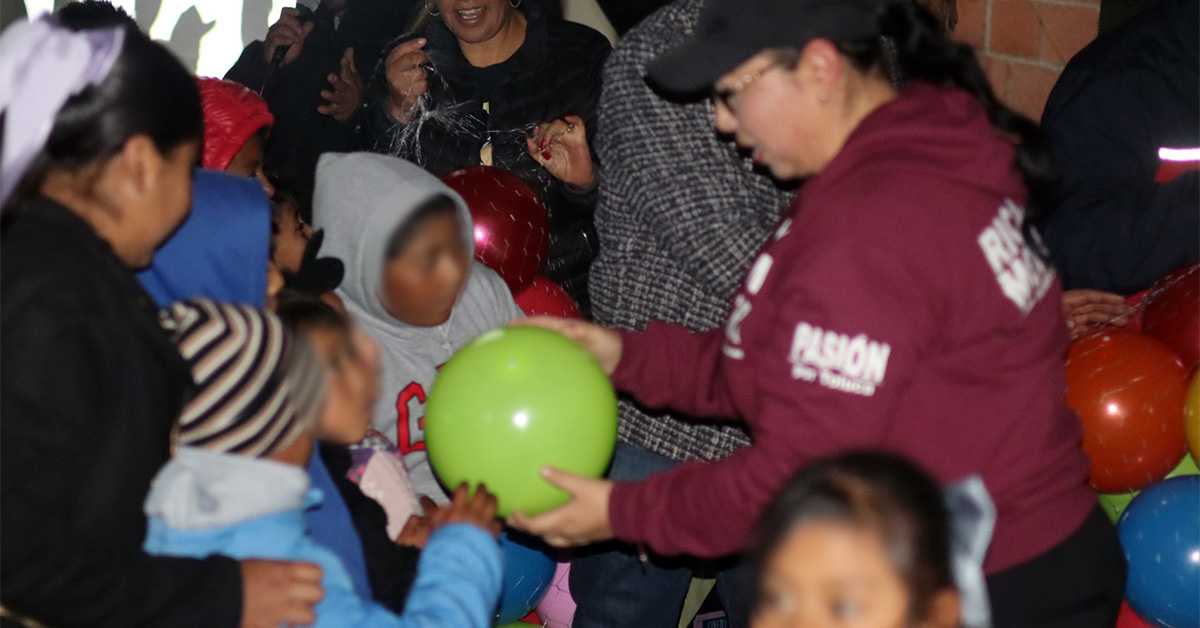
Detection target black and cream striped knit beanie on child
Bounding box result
[163,299,325,457]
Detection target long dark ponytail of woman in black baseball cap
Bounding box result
[839,0,1057,257]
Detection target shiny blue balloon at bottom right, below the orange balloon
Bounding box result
[1117,476,1200,628]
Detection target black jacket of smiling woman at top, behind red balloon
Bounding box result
[364,2,610,312]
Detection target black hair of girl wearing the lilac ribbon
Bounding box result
[8,25,204,212]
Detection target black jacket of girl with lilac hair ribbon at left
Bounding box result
[0,198,241,628]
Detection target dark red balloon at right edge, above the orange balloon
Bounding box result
[1142,262,1200,372]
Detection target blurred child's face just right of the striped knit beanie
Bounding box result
[308,325,374,444]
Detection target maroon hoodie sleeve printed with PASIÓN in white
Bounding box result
[608,243,937,557]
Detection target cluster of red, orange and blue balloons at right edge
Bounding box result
[1067,263,1200,628]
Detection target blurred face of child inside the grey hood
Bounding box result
[382,215,470,327]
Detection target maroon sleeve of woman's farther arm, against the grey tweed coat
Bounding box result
[612,322,737,419]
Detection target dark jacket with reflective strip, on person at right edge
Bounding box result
[1042,0,1200,294]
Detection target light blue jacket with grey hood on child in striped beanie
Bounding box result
[145,447,500,628]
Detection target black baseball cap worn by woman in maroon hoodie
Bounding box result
[648,0,886,94]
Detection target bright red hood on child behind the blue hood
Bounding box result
[196,78,275,171]
